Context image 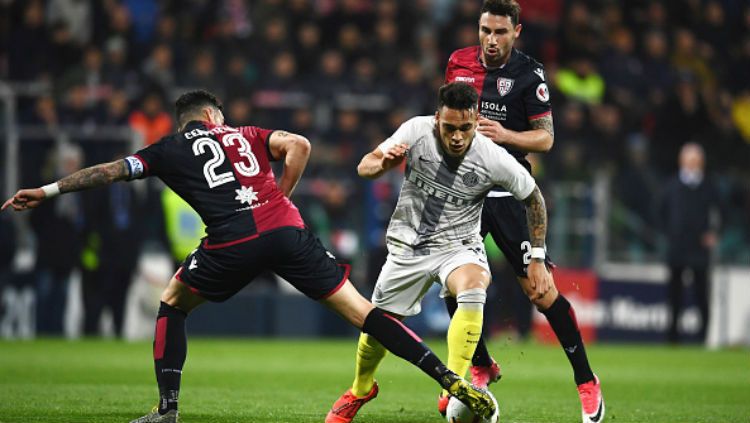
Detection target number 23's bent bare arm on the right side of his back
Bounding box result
[268,131,311,197]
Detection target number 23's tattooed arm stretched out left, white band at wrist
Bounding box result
[1,160,129,211]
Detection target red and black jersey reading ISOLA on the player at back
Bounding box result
[445,46,552,171]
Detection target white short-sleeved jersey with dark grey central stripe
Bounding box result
[378,116,536,255]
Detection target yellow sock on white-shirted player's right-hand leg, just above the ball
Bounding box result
[443,294,484,395]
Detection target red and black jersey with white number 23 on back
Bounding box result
[125,121,305,248]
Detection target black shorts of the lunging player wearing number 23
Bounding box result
[175,227,349,302]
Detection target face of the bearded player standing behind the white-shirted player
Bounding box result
[479,12,521,67]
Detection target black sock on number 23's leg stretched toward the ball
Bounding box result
[362,308,455,388]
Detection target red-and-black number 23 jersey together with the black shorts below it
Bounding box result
[125,121,349,301]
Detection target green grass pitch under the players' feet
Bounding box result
[0,339,750,423]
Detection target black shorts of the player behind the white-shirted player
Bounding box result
[481,196,554,278]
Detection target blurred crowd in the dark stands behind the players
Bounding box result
[0,0,750,338]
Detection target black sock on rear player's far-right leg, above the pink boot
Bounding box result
[542,294,594,385]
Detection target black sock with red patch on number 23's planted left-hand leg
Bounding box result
[154,302,187,414]
